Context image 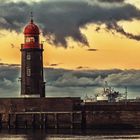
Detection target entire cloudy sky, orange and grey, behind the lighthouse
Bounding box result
[0,0,140,96]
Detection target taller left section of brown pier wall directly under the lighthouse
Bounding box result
[0,97,82,129]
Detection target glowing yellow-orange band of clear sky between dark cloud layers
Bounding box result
[0,21,140,69]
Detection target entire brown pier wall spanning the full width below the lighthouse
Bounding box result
[0,98,140,129]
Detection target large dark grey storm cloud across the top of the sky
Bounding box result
[0,0,140,47]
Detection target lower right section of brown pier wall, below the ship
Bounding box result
[83,102,140,128]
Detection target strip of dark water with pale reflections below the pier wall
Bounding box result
[0,130,140,140]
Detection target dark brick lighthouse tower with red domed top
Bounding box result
[21,16,45,97]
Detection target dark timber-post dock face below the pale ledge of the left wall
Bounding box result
[6,111,82,129]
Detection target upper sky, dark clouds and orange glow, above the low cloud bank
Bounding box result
[0,0,140,69]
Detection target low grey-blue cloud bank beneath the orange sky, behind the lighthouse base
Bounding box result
[0,63,140,98]
